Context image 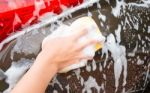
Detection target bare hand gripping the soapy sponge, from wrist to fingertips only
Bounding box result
[36,29,98,71]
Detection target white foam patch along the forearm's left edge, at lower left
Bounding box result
[3,58,33,93]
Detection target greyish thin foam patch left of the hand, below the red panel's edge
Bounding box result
[11,31,45,56]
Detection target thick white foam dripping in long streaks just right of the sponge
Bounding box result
[102,34,127,92]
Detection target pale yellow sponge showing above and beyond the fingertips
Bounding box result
[70,17,105,51]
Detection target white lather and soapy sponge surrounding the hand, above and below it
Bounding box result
[42,17,105,73]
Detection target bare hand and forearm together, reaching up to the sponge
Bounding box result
[11,29,97,93]
